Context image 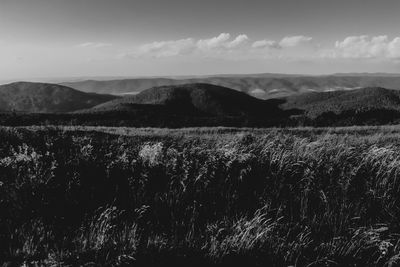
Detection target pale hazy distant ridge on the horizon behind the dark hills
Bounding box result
[62,73,400,99]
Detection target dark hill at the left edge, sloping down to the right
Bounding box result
[0,82,116,113]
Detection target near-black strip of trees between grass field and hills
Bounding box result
[0,109,400,128]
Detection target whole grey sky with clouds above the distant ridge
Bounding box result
[0,0,400,80]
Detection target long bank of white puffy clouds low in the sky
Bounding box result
[120,33,400,60]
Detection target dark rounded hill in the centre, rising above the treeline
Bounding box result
[91,83,273,116]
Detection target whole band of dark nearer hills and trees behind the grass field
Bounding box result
[0,81,400,127]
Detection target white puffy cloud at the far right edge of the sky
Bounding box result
[329,35,400,59]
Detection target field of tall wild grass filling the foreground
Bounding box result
[0,126,400,266]
